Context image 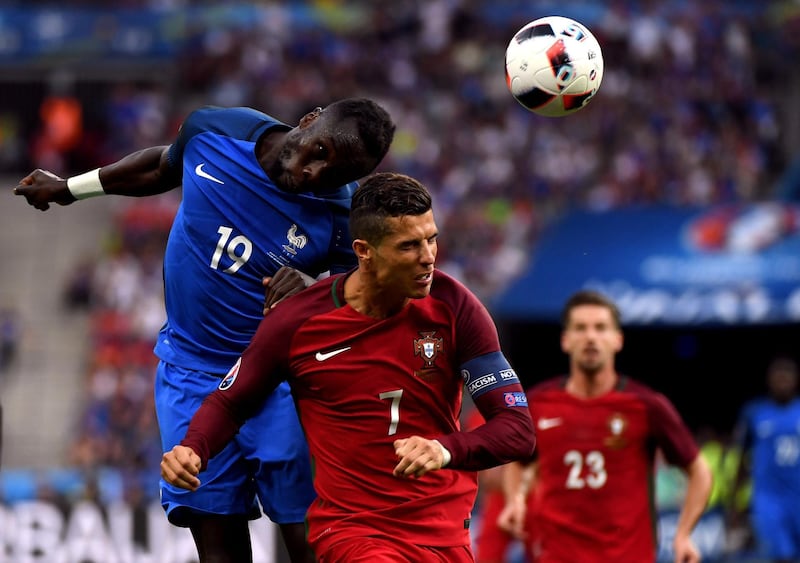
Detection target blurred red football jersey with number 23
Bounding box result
[528,377,698,563]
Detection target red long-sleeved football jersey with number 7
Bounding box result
[182,271,533,554]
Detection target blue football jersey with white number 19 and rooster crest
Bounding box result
[155,107,356,374]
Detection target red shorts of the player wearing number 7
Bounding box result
[317,537,475,563]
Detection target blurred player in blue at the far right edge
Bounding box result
[735,357,800,563]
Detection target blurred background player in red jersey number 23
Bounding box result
[501,291,712,563]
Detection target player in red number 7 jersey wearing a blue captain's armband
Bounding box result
[161,173,535,563]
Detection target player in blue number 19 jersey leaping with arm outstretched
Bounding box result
[14,98,395,563]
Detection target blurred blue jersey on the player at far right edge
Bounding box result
[738,399,800,503]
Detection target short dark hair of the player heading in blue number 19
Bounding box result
[325,98,396,163]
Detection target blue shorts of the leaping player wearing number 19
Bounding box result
[155,362,316,527]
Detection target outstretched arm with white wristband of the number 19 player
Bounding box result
[14,146,181,211]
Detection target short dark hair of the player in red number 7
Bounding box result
[350,172,433,244]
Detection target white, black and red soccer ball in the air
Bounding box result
[506,16,603,117]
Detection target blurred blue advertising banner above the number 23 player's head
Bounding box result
[490,202,800,325]
